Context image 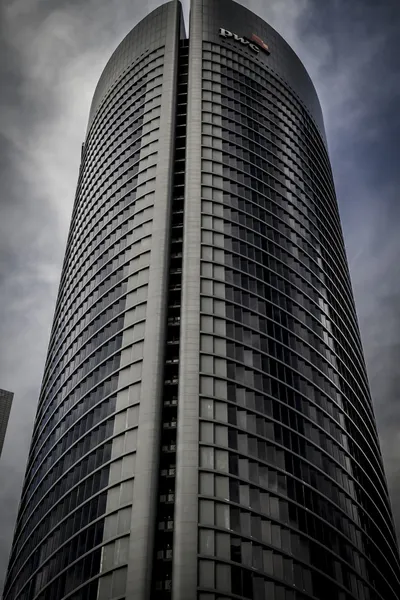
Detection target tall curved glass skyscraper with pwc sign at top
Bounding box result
[4,0,400,600]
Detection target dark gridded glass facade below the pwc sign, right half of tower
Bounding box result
[199,43,398,600]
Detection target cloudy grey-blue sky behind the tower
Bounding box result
[0,0,400,590]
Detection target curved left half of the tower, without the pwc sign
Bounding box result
[4,3,181,600]
